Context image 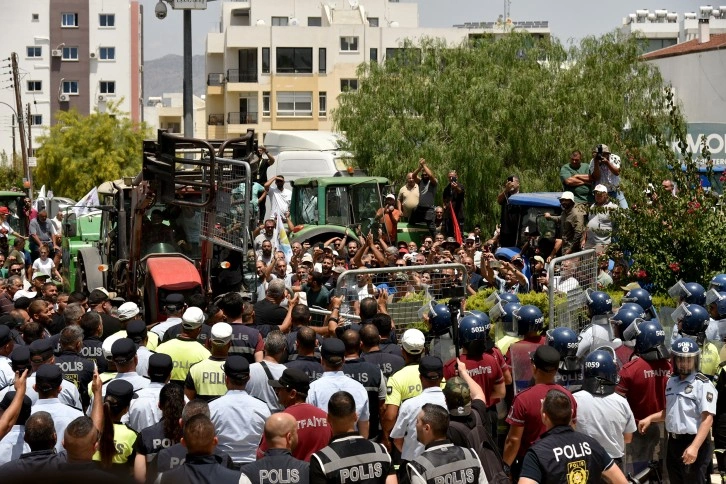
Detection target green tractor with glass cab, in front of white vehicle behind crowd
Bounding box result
[290,176,428,244]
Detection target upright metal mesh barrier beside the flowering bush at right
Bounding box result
[547,249,598,332]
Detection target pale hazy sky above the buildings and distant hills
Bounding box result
[141,0,705,60]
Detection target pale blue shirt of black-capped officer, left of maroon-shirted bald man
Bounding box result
[209,390,270,463]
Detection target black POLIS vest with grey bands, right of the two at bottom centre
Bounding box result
[408,442,482,484]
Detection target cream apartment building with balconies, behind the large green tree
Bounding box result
[206,0,550,139]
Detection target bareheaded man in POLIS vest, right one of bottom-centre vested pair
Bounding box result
[406,403,488,484]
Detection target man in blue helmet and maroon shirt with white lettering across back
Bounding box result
[615,321,671,474]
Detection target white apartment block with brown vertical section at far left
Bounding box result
[0,0,143,160]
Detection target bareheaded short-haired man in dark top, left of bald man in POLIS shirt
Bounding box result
[157,415,240,484]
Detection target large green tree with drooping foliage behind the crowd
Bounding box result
[333,32,668,229]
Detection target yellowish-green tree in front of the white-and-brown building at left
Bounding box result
[34,101,147,199]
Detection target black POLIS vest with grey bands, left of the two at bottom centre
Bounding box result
[310,433,392,484]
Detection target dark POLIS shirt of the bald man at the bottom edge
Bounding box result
[240,449,310,484]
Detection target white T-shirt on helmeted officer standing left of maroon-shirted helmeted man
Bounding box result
[572,390,637,459]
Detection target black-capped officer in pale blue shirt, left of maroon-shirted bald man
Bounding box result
[209,355,270,469]
